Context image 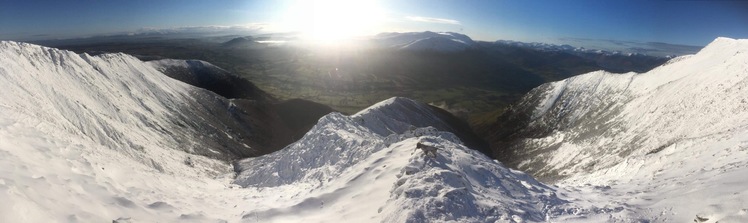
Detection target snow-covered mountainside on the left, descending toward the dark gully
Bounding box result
[0,41,272,222]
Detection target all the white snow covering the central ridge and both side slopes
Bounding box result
[0,39,748,222]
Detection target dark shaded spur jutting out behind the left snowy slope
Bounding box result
[146,59,334,154]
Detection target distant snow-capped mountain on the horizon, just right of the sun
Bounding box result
[372,31,475,52]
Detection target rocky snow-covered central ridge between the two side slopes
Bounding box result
[235,109,586,222]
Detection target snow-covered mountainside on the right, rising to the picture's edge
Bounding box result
[490,38,748,222]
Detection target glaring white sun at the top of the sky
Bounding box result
[287,0,382,42]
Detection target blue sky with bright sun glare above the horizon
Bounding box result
[0,0,748,46]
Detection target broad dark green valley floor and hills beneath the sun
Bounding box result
[41,32,666,122]
